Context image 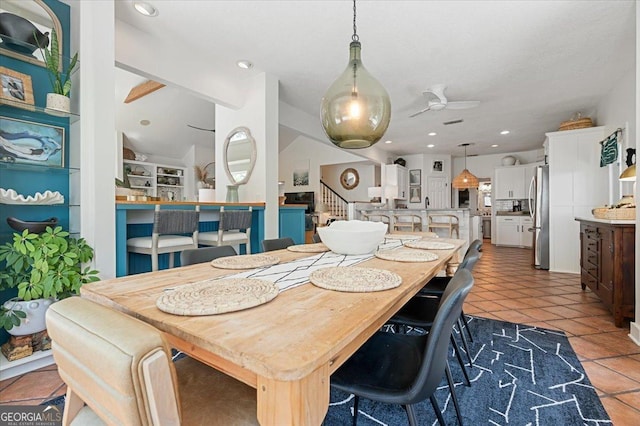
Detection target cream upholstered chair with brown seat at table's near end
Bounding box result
[47,297,258,426]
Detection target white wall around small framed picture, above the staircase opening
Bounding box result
[278,136,370,205]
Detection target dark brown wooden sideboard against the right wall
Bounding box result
[576,218,636,327]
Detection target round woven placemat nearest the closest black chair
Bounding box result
[309,266,402,293]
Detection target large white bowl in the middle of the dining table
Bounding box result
[318,220,388,254]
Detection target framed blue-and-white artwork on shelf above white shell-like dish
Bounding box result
[0,117,64,167]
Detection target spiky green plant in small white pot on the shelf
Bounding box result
[38,29,78,112]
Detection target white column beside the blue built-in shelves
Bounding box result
[78,1,117,279]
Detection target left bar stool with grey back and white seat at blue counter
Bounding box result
[127,204,200,271]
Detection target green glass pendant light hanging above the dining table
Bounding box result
[320,0,391,149]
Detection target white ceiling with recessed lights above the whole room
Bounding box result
[116,0,635,156]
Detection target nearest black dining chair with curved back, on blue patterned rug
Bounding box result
[331,269,473,426]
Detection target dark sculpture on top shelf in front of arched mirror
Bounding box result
[0,12,49,55]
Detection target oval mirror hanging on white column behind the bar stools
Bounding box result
[223,127,256,185]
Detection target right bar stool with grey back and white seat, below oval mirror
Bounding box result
[198,206,253,254]
